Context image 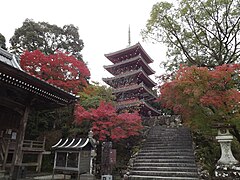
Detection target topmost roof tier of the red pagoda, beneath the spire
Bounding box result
[105,43,153,64]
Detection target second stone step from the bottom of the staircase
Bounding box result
[130,171,198,177]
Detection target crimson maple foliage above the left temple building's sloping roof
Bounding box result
[20,50,90,93]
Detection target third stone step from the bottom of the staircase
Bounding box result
[134,162,197,168]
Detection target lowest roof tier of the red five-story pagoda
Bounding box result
[117,99,161,116]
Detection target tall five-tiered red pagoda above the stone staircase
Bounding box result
[103,43,160,117]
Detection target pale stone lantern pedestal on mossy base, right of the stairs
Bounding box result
[215,128,240,179]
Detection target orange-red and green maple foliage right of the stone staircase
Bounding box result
[159,64,240,120]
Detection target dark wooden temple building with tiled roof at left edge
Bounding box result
[0,48,77,179]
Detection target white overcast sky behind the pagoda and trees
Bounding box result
[0,0,166,84]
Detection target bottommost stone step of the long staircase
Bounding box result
[128,175,199,180]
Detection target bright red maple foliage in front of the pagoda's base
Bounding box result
[75,102,142,141]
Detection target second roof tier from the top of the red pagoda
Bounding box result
[103,55,155,75]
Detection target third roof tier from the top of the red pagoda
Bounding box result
[102,68,157,88]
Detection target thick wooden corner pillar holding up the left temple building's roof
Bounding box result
[10,104,30,179]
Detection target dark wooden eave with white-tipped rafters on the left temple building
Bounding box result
[0,61,77,109]
